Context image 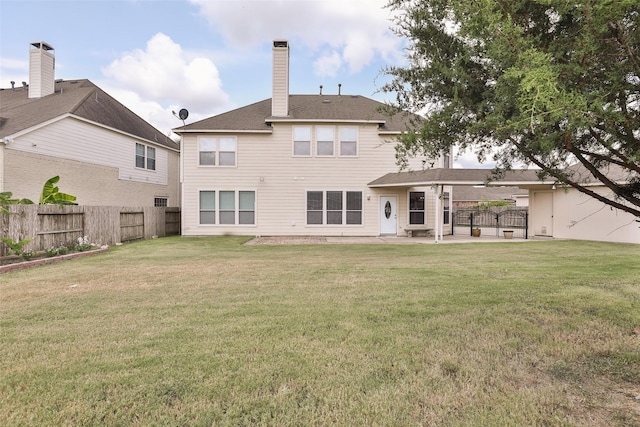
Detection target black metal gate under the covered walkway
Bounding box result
[453,208,529,239]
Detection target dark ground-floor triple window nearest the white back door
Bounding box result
[307,191,362,225]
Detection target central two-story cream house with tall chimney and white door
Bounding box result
[174,40,450,236]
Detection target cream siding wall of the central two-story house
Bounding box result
[182,123,440,236]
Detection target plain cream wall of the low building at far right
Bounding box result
[531,187,640,244]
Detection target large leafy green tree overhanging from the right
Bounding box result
[383,0,640,217]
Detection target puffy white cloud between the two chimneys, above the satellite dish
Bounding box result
[101,33,229,131]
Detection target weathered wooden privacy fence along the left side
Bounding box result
[0,205,180,256]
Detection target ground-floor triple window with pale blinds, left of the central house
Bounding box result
[200,191,256,225]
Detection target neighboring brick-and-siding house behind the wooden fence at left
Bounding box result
[0,42,180,207]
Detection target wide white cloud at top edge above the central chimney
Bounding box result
[191,0,402,76]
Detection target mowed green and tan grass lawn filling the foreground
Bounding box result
[0,237,640,426]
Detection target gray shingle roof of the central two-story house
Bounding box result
[175,95,419,133]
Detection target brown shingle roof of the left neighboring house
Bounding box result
[0,79,179,150]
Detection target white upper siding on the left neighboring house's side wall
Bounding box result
[7,117,168,185]
